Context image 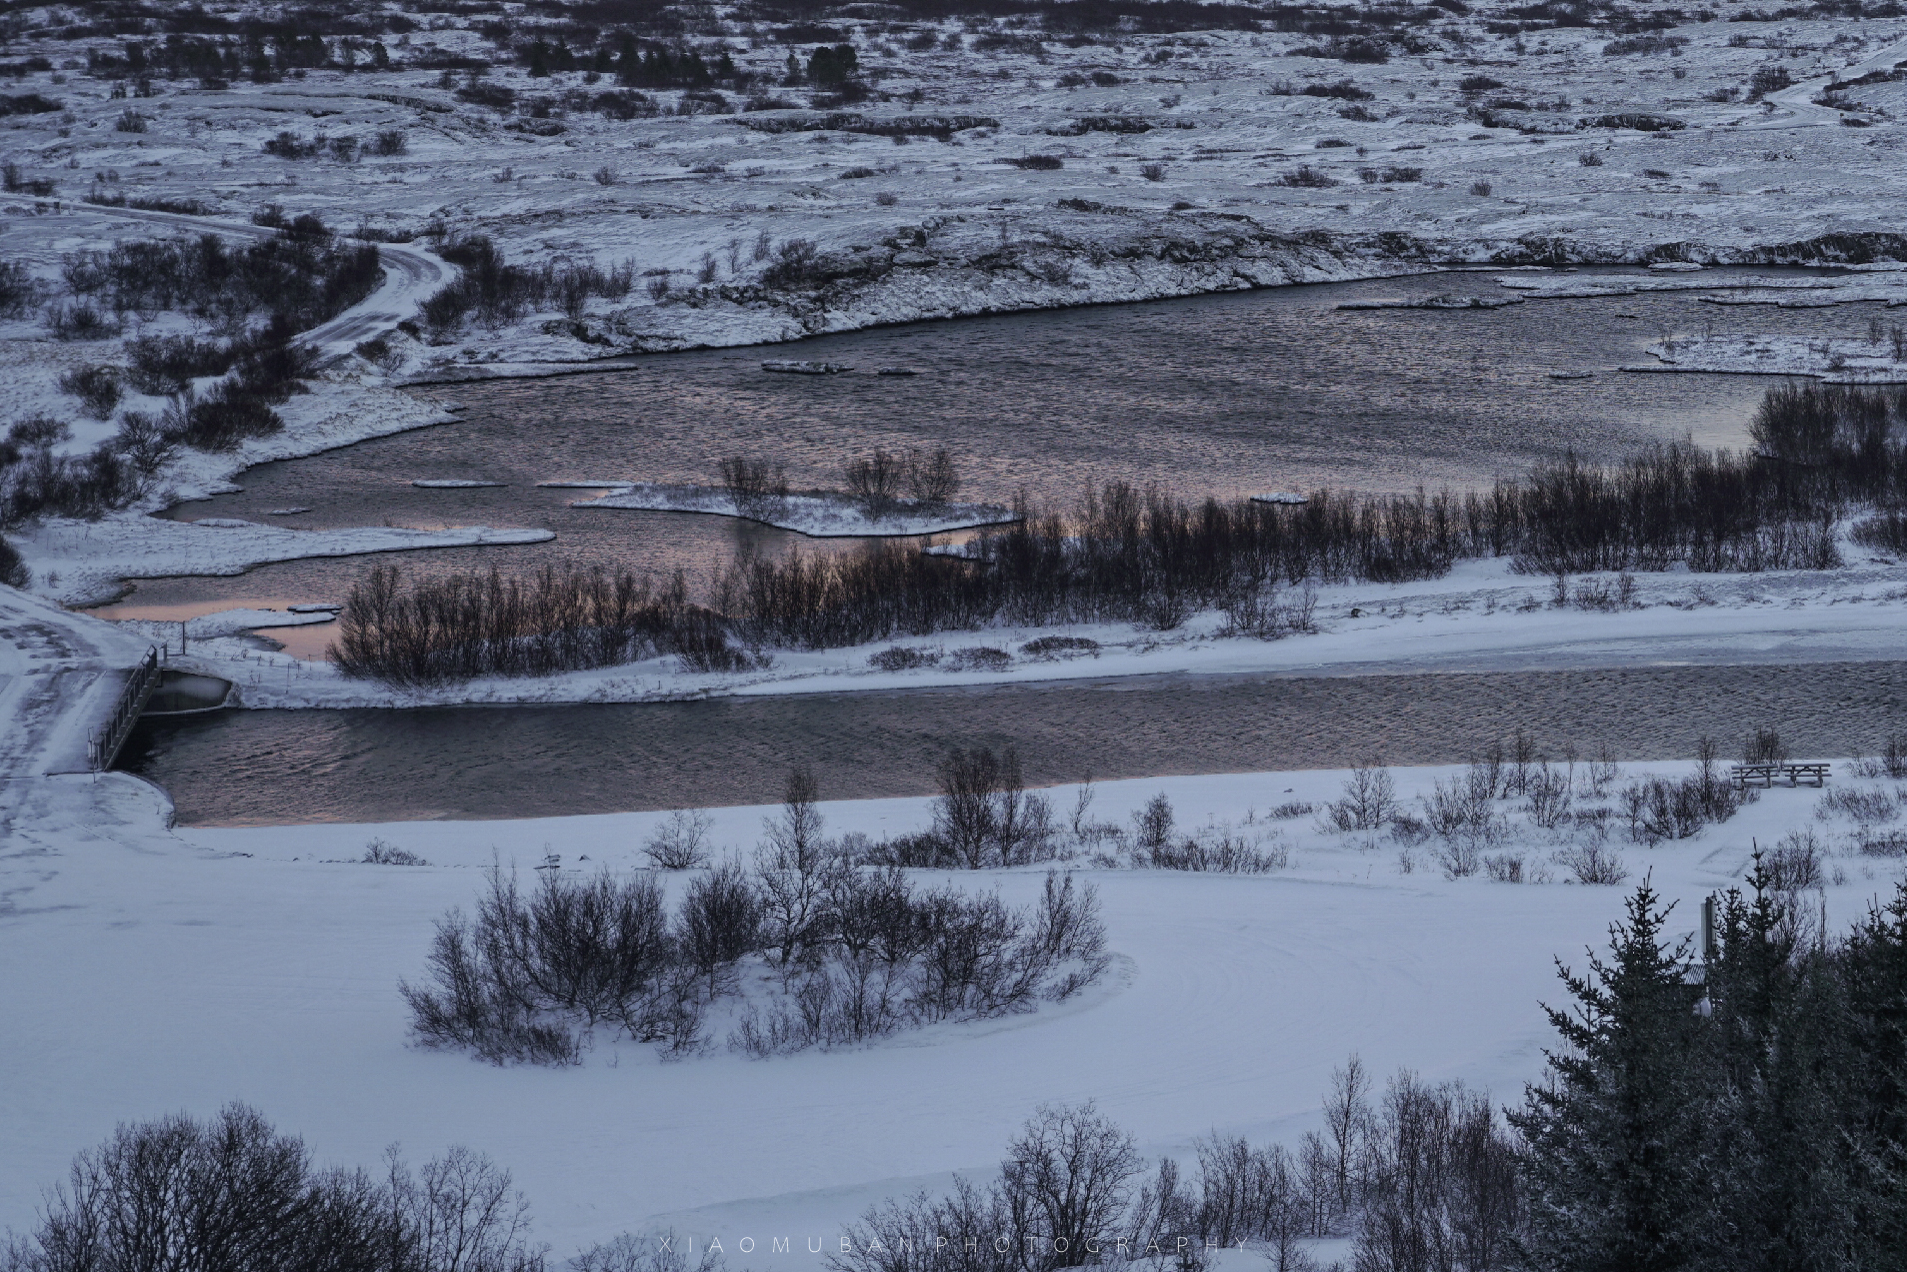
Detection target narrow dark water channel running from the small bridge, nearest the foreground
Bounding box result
[120,662,1907,826]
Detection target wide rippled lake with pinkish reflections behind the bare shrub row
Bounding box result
[89,271,1867,654]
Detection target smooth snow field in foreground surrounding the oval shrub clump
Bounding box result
[0,765,1901,1266]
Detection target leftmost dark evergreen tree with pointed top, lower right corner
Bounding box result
[1510,881,1712,1272]
